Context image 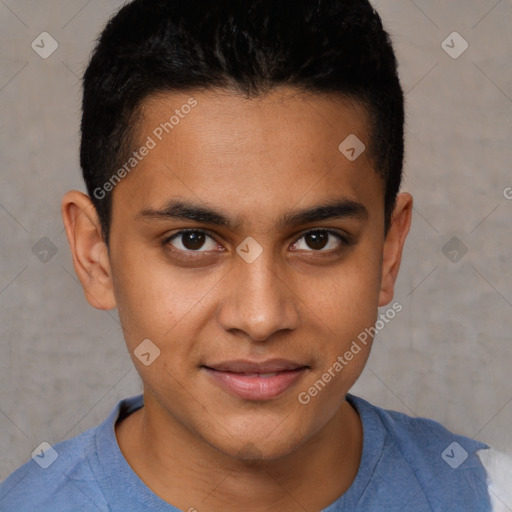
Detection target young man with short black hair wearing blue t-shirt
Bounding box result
[0,0,510,512]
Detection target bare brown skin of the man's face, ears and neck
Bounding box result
[62,88,412,512]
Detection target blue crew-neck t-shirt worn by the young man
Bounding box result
[0,395,512,512]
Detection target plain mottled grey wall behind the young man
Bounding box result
[0,0,512,479]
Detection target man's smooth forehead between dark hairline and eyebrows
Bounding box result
[114,88,383,227]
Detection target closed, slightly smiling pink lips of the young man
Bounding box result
[201,359,310,401]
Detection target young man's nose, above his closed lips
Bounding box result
[218,251,300,342]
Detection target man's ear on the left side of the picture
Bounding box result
[62,190,116,309]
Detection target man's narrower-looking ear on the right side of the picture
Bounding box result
[379,193,413,307]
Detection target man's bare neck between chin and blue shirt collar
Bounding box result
[116,396,362,512]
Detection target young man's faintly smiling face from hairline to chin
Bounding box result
[66,89,410,459]
